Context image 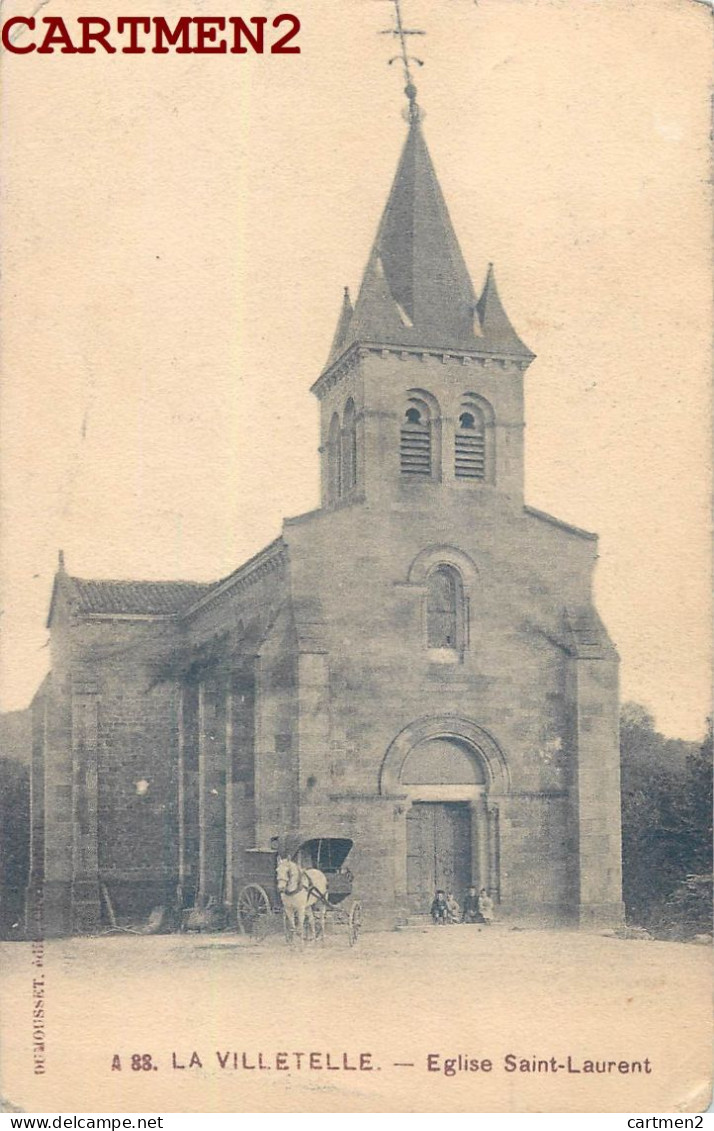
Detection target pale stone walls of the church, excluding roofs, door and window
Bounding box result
[31,436,621,933]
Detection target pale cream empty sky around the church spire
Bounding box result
[0,0,712,739]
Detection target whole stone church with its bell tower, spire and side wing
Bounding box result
[28,89,622,935]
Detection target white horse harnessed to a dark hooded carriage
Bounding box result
[236,837,362,947]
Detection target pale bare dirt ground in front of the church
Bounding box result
[0,924,712,1113]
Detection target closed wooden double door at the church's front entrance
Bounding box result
[406,801,473,914]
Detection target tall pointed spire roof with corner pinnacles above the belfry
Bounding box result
[328,120,532,364]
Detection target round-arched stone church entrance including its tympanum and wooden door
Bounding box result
[379,716,510,914]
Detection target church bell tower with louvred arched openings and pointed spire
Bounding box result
[312,83,534,508]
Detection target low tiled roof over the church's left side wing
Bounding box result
[69,577,213,616]
